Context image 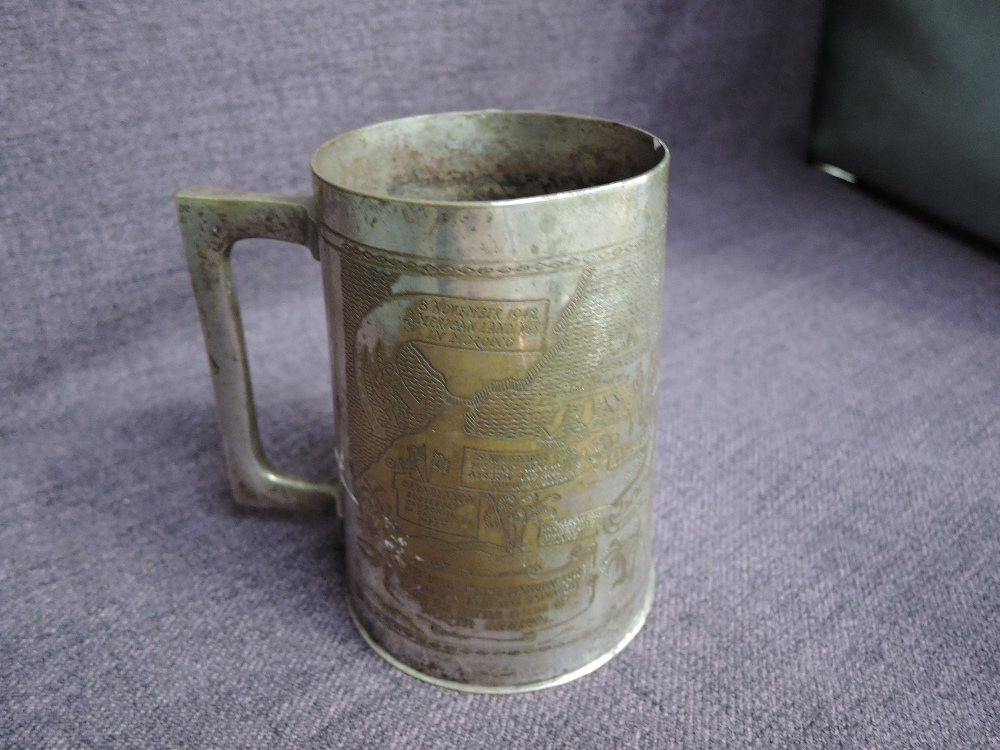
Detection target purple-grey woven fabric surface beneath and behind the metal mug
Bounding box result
[0,0,1000,748]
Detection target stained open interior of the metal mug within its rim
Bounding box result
[312,110,666,203]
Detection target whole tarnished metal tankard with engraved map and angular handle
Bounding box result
[177,110,669,693]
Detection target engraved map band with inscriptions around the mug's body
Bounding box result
[338,228,663,648]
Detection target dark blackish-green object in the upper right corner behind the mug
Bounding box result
[811,0,1000,245]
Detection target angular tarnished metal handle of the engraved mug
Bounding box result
[176,187,343,517]
